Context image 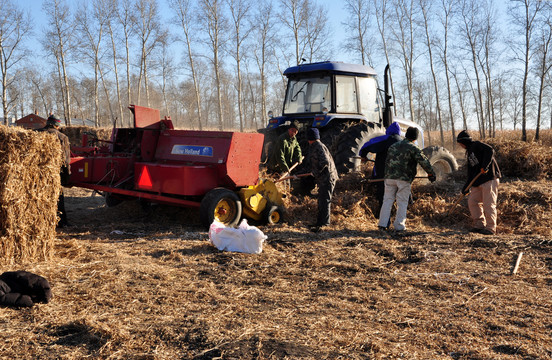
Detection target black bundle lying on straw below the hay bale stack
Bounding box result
[0,271,52,307]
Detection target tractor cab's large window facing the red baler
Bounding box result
[284,76,331,114]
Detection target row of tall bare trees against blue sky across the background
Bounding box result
[0,0,552,143]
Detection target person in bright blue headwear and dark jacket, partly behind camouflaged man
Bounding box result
[359,122,402,218]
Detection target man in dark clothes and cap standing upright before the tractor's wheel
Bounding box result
[307,128,338,232]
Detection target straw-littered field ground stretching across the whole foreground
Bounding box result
[0,131,552,359]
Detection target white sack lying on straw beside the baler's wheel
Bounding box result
[209,219,267,254]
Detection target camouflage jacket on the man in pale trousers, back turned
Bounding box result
[385,139,435,182]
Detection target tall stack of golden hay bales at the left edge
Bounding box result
[0,126,62,263]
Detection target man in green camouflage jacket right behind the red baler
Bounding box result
[269,122,303,174]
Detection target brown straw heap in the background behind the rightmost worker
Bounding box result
[485,138,552,180]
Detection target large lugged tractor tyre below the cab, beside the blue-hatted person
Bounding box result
[332,122,385,174]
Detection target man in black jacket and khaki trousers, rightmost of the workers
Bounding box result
[456,130,502,235]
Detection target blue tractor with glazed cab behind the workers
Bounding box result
[259,61,458,178]
